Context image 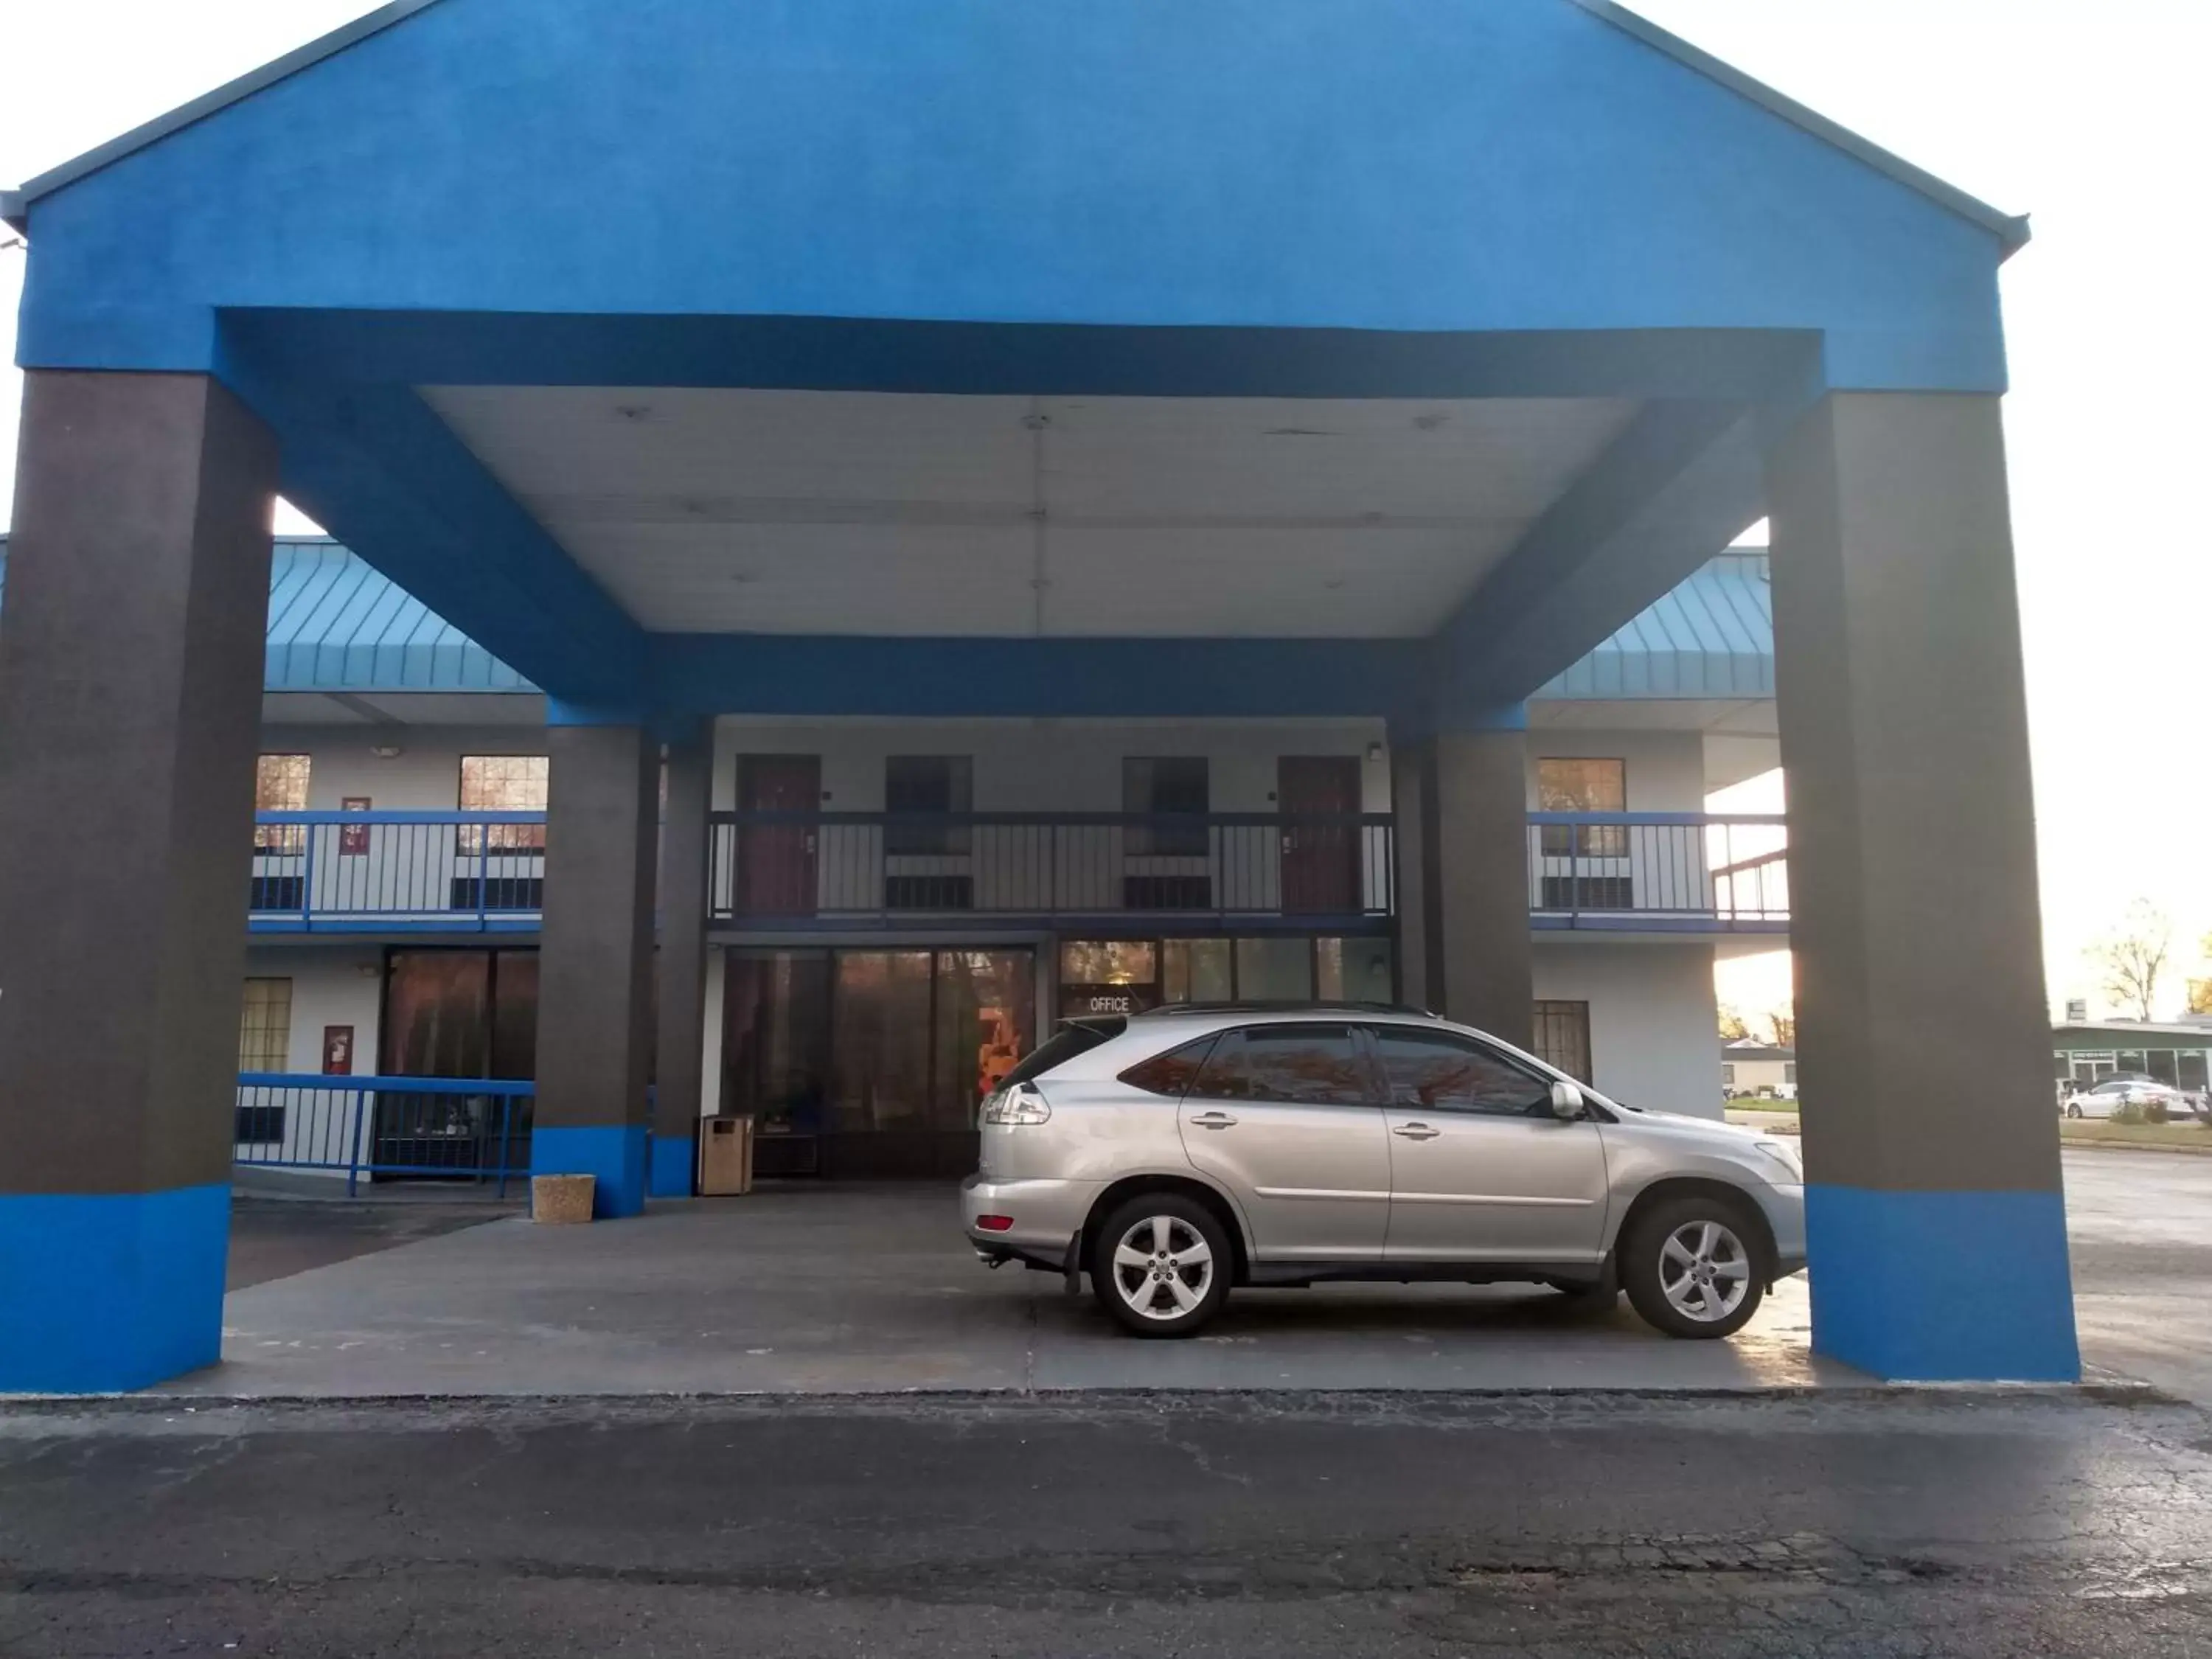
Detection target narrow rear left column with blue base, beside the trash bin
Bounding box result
[650,723,714,1199]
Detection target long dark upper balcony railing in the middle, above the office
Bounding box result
[708,812,1396,931]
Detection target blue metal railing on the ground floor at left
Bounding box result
[232,1071,538,1197]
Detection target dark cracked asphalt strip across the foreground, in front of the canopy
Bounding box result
[0,1391,2212,1659]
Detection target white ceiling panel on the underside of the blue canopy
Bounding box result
[422,387,1635,637]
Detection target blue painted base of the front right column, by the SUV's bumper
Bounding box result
[1805,1186,2081,1382]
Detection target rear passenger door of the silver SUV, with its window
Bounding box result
[1181,1024,1389,1261]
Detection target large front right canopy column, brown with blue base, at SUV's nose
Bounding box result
[1770,394,2079,1380]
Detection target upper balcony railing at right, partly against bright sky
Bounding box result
[1528,812,1790,933]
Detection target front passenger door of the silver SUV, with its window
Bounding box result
[1376,1029,1606,1261]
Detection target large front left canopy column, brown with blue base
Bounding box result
[0,369,276,1391]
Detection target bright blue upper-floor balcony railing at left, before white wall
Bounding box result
[246,812,546,933]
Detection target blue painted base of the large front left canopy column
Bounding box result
[0,1186,230,1394]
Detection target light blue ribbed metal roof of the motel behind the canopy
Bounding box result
[0,535,1774,699]
